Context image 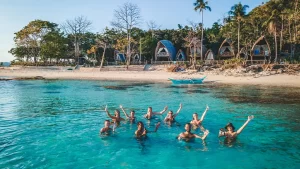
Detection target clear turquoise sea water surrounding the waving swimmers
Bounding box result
[0,81,300,168]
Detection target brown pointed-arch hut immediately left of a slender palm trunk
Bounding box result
[218,38,235,60]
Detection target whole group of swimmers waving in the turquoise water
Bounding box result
[100,104,254,142]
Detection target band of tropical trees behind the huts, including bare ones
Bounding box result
[9,0,300,66]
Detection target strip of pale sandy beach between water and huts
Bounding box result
[0,68,300,88]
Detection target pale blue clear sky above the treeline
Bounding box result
[0,0,266,62]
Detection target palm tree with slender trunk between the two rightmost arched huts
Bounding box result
[228,3,249,57]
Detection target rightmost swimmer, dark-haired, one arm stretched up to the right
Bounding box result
[219,115,254,143]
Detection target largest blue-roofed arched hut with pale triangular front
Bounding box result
[155,40,176,61]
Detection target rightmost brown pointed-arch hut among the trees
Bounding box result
[251,36,271,62]
